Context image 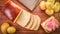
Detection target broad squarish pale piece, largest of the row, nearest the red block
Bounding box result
[16,10,31,27]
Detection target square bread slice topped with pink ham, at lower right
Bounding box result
[41,16,59,33]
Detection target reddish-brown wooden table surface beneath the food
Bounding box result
[0,0,60,34]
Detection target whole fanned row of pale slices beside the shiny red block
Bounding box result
[14,10,41,30]
